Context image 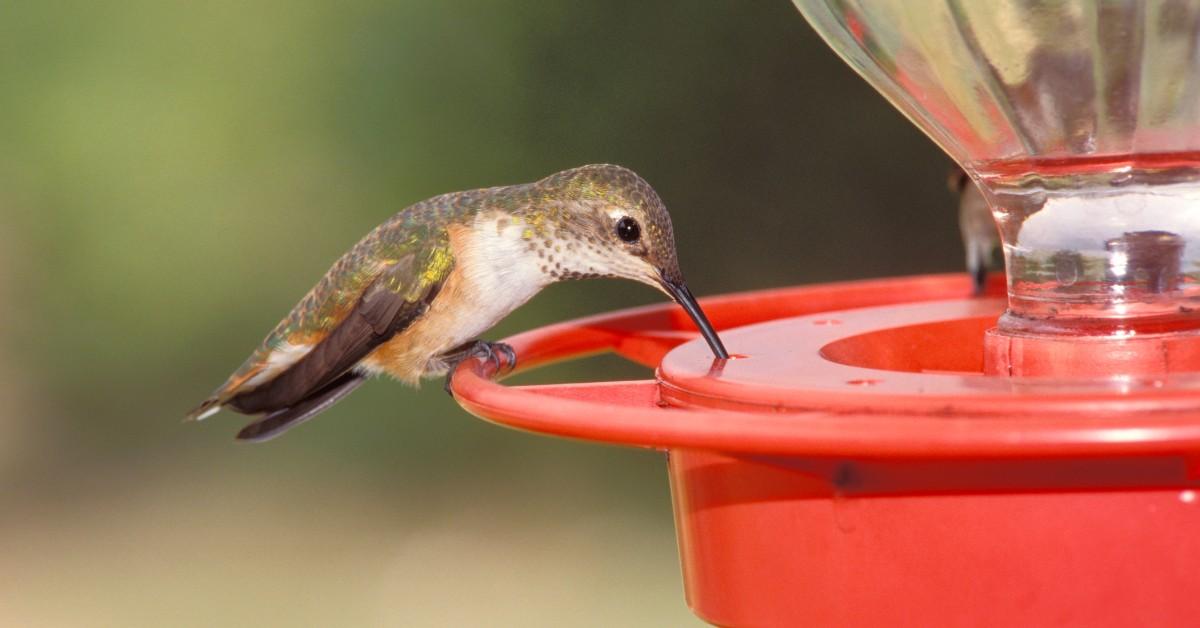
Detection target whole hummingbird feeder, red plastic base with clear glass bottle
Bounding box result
[452,0,1200,627]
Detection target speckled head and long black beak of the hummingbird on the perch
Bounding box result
[528,165,728,359]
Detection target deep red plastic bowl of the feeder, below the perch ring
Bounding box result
[670,450,1200,627]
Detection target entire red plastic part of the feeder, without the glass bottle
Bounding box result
[452,276,1200,626]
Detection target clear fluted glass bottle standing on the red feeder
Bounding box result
[796,0,1200,333]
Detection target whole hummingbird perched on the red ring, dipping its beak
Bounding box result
[186,165,728,441]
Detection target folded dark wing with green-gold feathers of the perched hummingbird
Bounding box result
[188,222,454,418]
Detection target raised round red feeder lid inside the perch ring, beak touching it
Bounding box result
[658,299,1200,418]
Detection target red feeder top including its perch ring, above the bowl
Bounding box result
[451,275,1200,459]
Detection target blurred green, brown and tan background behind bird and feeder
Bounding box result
[0,0,961,627]
